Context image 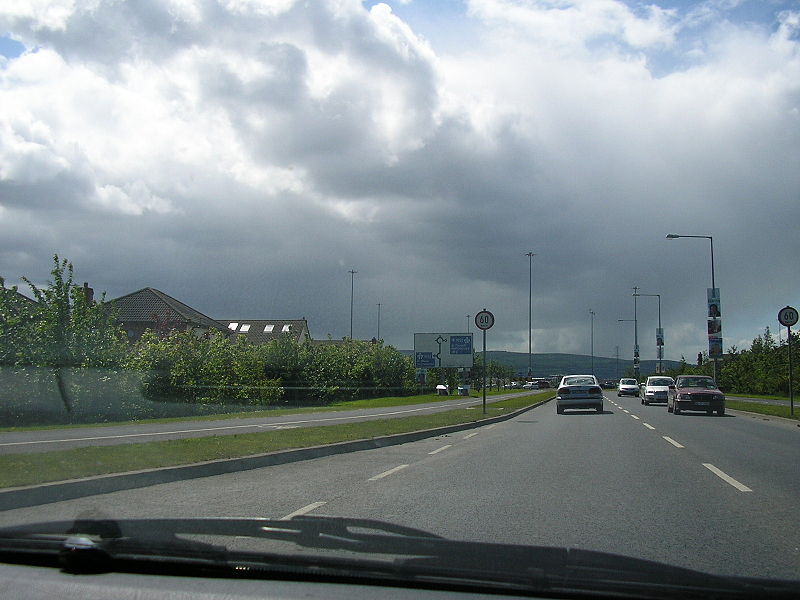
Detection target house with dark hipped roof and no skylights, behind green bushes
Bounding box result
[110,287,230,342]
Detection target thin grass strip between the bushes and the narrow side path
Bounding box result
[0,389,530,433]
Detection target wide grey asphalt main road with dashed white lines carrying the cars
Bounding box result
[0,394,800,579]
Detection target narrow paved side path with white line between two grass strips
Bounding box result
[0,392,520,454]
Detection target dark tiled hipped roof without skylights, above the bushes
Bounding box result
[111,287,225,331]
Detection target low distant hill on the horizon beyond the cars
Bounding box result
[401,350,680,379]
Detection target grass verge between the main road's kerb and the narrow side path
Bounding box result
[0,391,552,488]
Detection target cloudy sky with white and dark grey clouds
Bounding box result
[0,0,800,361]
